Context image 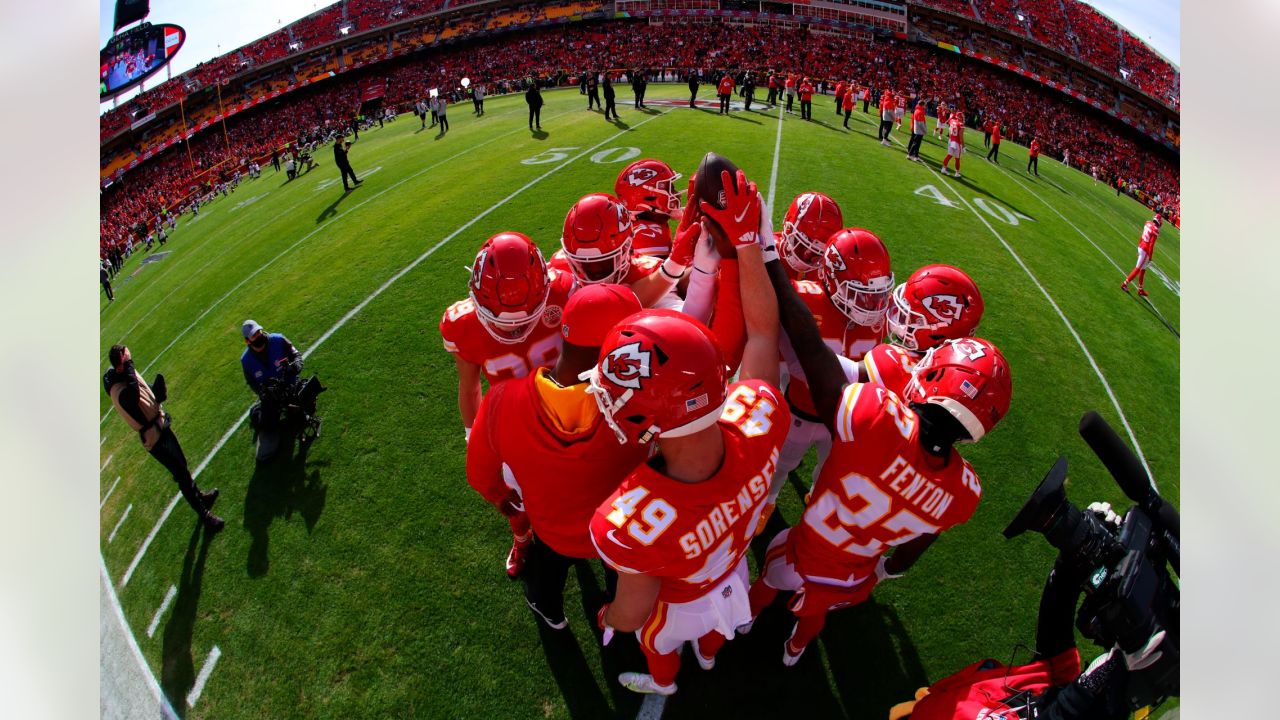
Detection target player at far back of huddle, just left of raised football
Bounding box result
[613,158,681,258]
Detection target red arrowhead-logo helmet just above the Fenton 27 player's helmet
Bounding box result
[888,265,983,352]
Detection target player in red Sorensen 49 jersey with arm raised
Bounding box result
[588,172,790,694]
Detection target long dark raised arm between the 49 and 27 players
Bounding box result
[764,260,846,433]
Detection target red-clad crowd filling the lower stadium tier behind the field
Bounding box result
[101,22,1178,263]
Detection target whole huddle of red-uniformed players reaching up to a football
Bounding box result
[440,159,1011,694]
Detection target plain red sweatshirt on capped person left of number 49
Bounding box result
[467,373,649,557]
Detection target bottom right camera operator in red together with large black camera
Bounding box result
[890,413,1180,720]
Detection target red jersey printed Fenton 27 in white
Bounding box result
[787,383,982,584]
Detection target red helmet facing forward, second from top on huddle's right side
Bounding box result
[818,228,893,328]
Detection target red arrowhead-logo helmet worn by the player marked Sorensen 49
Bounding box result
[581,309,727,445]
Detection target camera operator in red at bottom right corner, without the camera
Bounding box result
[890,503,1164,720]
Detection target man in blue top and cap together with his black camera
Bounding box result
[241,320,325,462]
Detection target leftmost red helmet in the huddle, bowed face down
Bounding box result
[468,232,552,345]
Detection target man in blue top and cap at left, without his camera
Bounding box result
[241,320,302,462]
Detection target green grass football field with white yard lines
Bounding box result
[99,86,1180,719]
